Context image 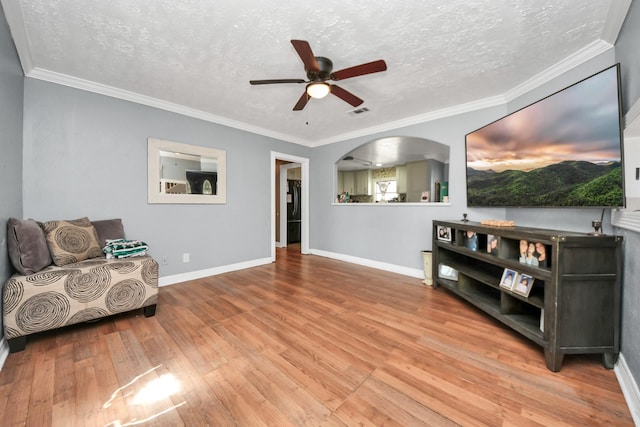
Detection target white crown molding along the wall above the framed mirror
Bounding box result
[26,68,308,145]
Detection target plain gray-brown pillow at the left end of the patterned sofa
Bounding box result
[7,218,51,275]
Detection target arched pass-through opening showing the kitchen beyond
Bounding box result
[336,136,449,203]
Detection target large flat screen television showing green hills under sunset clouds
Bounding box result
[465,64,625,208]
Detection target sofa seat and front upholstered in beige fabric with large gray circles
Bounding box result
[2,256,158,339]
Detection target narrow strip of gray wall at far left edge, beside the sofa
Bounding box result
[0,7,24,339]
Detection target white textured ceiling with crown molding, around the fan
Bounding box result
[1,0,631,146]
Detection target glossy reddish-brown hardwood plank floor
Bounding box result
[0,248,633,427]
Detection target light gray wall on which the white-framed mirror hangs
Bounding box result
[23,78,310,277]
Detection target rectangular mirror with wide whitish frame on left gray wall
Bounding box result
[147,138,227,203]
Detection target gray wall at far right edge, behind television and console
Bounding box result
[616,1,640,392]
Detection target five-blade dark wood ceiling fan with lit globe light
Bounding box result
[249,40,387,111]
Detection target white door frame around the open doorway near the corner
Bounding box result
[271,151,309,262]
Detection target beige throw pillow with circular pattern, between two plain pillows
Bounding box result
[40,217,103,266]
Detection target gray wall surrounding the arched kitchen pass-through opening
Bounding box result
[310,107,506,270]
